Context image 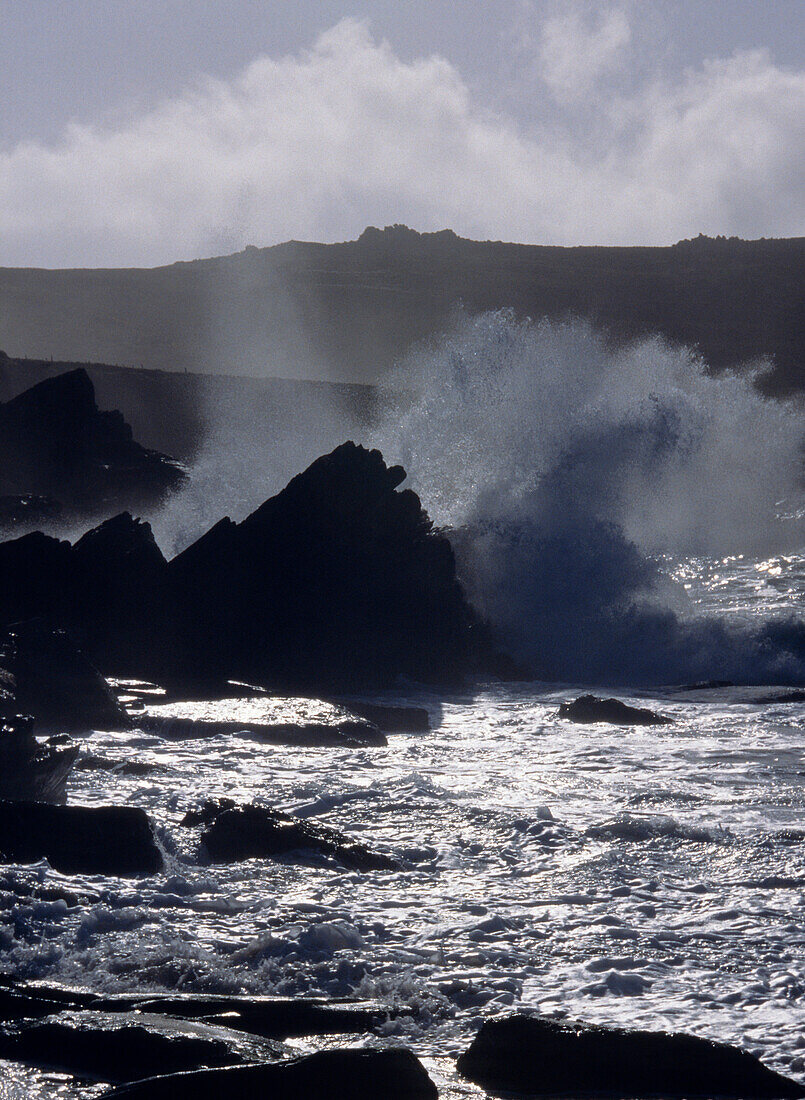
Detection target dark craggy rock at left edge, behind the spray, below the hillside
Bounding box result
[0,370,185,527]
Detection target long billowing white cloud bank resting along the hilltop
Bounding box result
[0,21,805,266]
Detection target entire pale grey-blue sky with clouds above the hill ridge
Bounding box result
[0,0,805,267]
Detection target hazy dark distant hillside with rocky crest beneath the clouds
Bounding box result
[0,227,805,393]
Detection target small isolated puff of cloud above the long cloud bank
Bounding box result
[539,8,631,101]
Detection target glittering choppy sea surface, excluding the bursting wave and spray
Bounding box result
[0,554,805,1096]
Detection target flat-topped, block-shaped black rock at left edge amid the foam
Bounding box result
[0,801,162,875]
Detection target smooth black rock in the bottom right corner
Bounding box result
[457,1016,805,1100]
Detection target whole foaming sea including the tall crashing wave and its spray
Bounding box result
[0,314,805,1100]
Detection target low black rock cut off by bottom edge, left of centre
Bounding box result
[112,1048,438,1100]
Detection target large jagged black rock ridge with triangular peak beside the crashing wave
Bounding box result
[0,443,511,693]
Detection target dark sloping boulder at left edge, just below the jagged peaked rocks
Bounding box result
[0,619,130,732]
